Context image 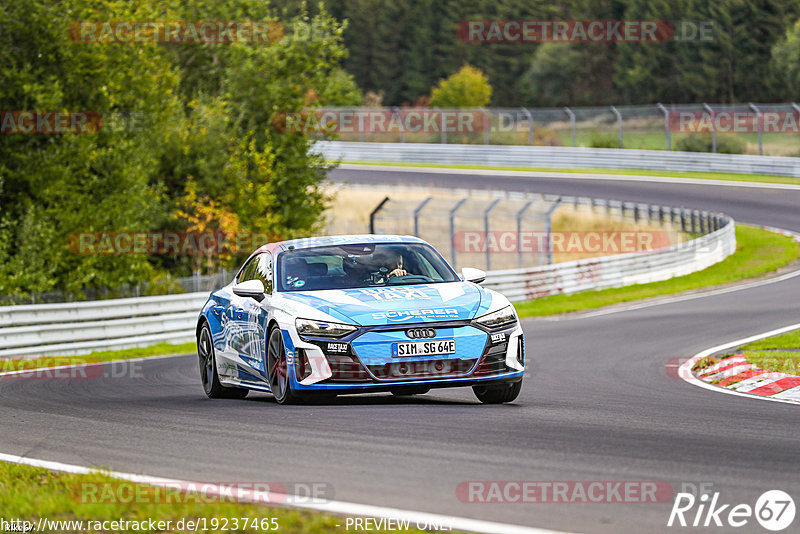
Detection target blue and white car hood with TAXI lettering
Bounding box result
[281,282,493,326]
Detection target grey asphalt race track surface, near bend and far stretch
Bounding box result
[0,169,800,533]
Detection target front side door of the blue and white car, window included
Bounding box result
[230,252,273,380]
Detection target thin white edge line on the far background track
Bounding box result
[338,163,800,191]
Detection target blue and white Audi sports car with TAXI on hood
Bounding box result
[197,235,525,404]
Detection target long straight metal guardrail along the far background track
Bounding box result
[314,141,800,178]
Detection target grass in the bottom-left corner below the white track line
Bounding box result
[0,462,438,534]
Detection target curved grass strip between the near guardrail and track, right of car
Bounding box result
[516,225,798,317]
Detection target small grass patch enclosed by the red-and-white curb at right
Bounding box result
[692,330,800,376]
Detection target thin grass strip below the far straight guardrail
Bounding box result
[341,161,800,185]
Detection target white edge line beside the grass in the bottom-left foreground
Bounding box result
[0,453,566,534]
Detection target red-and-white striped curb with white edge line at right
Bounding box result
[678,323,800,405]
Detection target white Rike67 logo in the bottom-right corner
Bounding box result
[667,490,795,532]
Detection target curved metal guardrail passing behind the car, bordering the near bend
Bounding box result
[0,207,736,358]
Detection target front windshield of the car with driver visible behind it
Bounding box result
[278,243,458,291]
